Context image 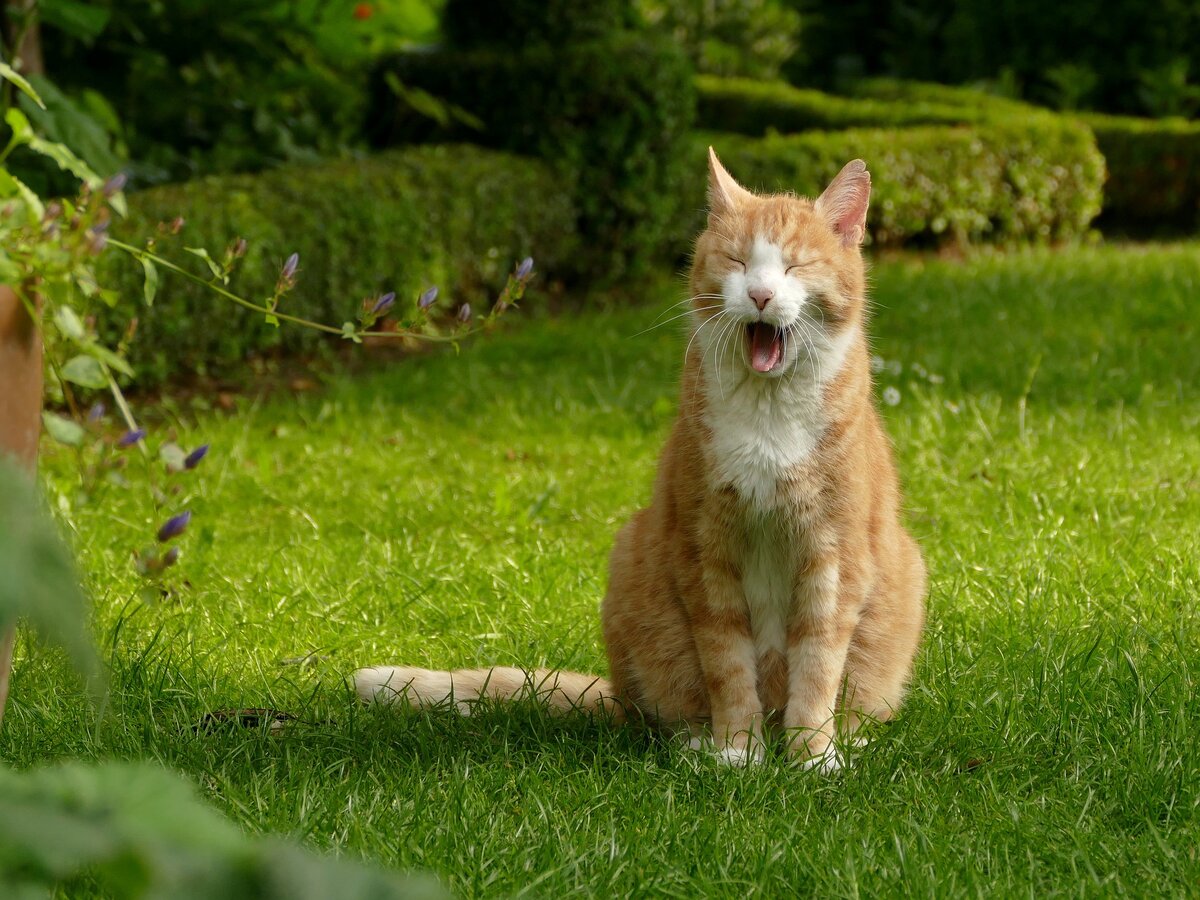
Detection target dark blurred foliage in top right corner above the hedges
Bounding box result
[785,0,1200,115]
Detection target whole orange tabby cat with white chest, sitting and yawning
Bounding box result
[355,150,925,770]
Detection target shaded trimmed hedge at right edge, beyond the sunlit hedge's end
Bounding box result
[1081,114,1200,230]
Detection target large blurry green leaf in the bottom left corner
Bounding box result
[0,762,445,900]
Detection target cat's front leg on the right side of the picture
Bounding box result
[784,554,858,772]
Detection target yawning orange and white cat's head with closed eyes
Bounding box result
[691,148,871,378]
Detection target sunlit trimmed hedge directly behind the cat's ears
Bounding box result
[677,118,1104,246]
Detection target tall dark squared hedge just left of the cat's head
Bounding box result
[374,32,695,276]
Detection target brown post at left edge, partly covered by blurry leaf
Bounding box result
[0,284,42,722]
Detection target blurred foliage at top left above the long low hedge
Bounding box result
[42,0,438,184]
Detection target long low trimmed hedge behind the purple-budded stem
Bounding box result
[100,145,576,385]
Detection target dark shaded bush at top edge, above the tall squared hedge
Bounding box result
[442,0,636,50]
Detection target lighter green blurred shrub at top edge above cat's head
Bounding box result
[637,0,800,78]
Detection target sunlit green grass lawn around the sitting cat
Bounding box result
[0,244,1200,896]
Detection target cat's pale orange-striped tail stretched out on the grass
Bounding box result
[354,666,629,722]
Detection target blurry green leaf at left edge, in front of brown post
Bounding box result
[0,457,100,678]
